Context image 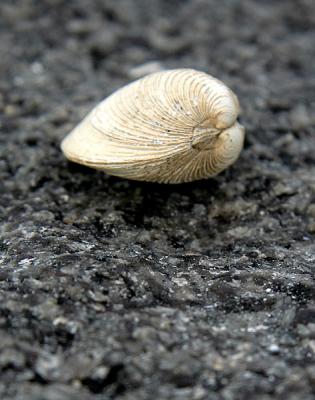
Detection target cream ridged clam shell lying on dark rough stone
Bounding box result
[61,69,244,183]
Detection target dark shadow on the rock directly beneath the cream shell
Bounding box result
[59,162,228,226]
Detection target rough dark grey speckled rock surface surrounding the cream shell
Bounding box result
[0,0,315,400]
